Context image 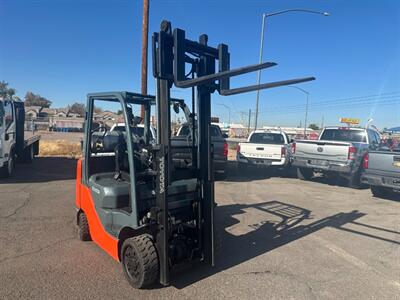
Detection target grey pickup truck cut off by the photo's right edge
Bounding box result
[361,146,400,198]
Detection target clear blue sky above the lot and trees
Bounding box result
[0,0,400,127]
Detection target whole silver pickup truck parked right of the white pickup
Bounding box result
[292,127,380,188]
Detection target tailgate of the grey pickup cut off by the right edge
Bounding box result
[368,151,400,177]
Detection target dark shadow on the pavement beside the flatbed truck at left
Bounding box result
[0,157,76,184]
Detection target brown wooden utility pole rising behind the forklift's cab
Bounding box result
[140,0,150,122]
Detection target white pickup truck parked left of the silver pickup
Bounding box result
[236,130,292,169]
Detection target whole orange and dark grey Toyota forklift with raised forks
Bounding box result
[76,21,314,288]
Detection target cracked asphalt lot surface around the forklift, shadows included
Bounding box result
[0,158,400,299]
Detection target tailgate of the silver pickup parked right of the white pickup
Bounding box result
[295,141,351,162]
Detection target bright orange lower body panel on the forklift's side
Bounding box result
[75,159,119,261]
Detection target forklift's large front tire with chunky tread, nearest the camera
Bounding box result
[121,234,159,289]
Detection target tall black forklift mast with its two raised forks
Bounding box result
[152,21,315,285]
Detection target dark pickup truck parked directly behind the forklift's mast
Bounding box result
[171,124,228,178]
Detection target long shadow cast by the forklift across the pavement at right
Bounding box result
[172,201,400,289]
